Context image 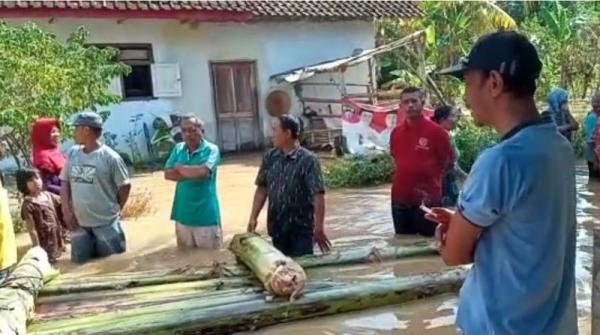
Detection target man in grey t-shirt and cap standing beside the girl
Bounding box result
[60,112,131,263]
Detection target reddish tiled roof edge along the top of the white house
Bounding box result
[0,0,421,20]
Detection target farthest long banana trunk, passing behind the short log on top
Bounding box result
[40,242,438,296]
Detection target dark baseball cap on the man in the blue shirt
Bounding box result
[438,31,542,82]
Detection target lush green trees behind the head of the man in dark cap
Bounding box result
[378,1,600,104]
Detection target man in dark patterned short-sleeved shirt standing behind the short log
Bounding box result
[248,115,331,257]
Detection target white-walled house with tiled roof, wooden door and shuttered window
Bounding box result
[0,0,420,165]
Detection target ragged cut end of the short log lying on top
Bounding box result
[265,260,306,301]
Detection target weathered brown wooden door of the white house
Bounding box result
[211,61,260,152]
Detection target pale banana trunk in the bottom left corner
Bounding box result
[0,247,58,335]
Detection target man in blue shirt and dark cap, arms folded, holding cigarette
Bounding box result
[428,32,578,335]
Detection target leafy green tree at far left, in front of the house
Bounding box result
[0,23,130,166]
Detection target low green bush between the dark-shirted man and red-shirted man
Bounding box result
[323,152,394,188]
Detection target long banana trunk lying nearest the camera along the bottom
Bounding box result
[29,269,465,335]
